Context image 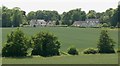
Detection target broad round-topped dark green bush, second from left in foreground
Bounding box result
[32,32,60,57]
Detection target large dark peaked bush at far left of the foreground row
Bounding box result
[2,29,29,57]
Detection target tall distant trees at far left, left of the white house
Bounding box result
[2,6,27,27]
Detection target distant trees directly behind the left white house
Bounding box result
[27,10,60,21]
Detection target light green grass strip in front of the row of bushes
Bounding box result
[2,54,118,64]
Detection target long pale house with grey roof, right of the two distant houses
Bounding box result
[73,19,100,27]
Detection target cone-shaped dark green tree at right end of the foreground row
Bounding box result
[97,30,115,53]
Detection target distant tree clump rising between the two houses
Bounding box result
[61,8,86,26]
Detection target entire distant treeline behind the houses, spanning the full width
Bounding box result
[0,6,120,27]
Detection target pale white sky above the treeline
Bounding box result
[0,0,120,14]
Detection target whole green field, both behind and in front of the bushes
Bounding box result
[2,27,118,64]
